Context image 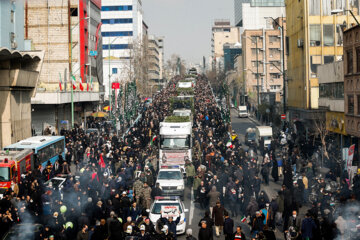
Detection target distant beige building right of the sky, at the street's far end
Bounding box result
[211,19,240,68]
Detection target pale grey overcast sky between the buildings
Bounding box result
[142,0,234,63]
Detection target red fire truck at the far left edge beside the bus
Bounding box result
[0,149,34,191]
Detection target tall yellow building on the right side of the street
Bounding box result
[286,0,359,124]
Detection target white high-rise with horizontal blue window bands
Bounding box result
[101,0,147,98]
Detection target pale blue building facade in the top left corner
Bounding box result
[0,0,25,50]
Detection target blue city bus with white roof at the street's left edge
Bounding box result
[4,136,65,169]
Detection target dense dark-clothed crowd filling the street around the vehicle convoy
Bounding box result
[0,77,360,240]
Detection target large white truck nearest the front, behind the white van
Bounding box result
[159,118,192,173]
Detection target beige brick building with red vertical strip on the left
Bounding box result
[25,0,103,134]
